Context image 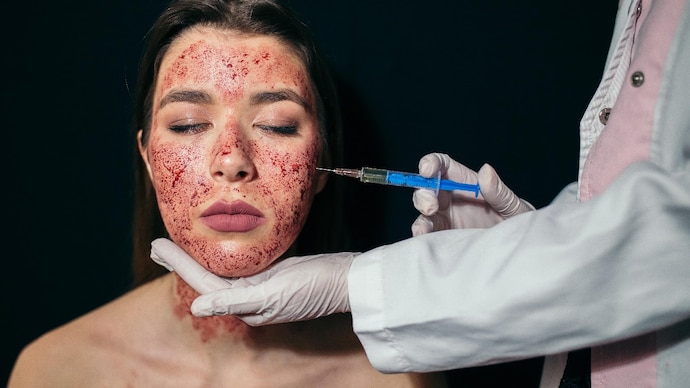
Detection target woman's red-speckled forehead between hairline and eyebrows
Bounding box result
[158,27,308,89]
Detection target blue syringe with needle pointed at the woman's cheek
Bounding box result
[316,167,479,197]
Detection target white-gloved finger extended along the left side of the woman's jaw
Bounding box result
[151,238,232,294]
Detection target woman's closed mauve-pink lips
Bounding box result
[201,200,266,233]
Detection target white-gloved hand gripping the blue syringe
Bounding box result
[412,153,534,236]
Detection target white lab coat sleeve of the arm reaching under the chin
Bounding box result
[348,0,690,387]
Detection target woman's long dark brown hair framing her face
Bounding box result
[132,0,349,286]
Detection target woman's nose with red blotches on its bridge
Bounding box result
[211,136,256,182]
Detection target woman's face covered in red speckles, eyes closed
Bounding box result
[139,27,326,277]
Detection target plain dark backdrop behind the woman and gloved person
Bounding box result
[2,0,617,386]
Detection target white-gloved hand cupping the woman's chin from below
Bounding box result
[151,238,357,326]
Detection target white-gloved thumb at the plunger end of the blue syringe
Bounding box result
[477,164,534,218]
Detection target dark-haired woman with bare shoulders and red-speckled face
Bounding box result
[9,0,445,388]
